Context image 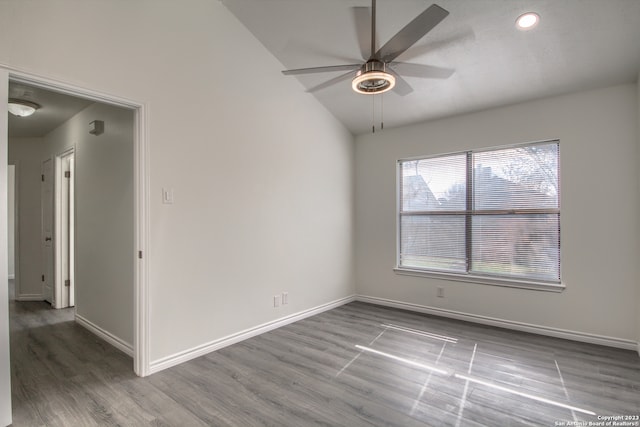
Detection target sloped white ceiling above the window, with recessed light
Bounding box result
[222,0,640,134]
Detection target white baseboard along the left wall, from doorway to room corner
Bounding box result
[149,296,355,374]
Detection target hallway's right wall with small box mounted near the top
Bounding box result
[43,104,135,347]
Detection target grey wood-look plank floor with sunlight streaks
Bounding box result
[10,290,640,427]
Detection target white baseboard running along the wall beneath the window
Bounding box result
[355,295,640,355]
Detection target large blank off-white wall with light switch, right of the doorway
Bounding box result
[0,0,355,368]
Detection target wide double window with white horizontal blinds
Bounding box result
[398,141,560,285]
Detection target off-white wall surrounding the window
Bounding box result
[356,85,640,343]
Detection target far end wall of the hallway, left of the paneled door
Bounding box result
[9,138,45,300]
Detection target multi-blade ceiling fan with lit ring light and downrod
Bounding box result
[282,0,454,96]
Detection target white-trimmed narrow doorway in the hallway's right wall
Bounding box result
[55,151,75,308]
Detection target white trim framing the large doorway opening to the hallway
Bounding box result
[0,64,150,377]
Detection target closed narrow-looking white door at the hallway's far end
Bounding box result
[41,159,55,306]
